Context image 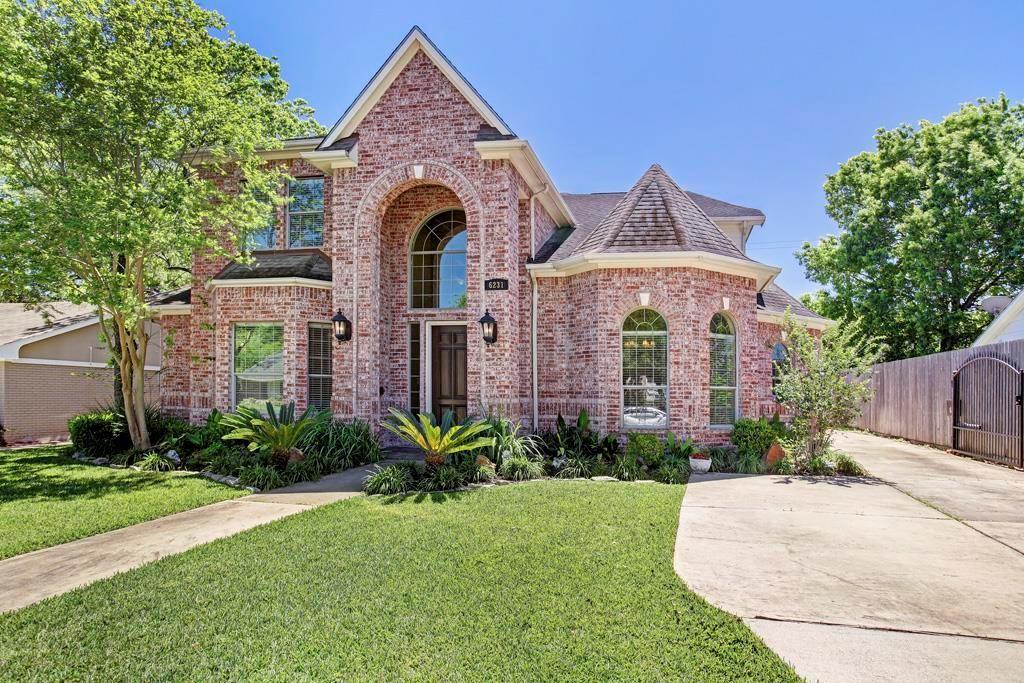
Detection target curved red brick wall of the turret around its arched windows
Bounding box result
[538,268,774,443]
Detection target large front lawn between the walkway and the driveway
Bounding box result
[0,481,796,681]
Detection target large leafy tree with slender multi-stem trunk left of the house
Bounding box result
[0,0,318,447]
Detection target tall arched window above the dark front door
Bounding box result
[410,209,466,308]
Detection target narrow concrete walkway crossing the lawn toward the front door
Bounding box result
[0,458,385,612]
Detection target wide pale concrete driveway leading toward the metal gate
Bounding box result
[675,434,1024,681]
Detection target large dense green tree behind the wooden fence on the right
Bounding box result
[798,96,1024,359]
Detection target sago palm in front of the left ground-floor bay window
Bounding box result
[220,401,330,469]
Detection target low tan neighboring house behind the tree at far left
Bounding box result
[0,301,162,443]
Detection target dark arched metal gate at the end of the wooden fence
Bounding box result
[952,357,1024,467]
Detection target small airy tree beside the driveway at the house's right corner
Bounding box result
[775,310,885,460]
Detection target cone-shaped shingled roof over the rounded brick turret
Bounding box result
[565,164,751,260]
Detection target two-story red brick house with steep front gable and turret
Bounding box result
[148,29,827,441]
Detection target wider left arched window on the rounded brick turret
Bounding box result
[623,308,669,429]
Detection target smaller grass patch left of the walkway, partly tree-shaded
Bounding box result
[0,446,245,559]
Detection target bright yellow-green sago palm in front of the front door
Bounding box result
[381,408,495,467]
